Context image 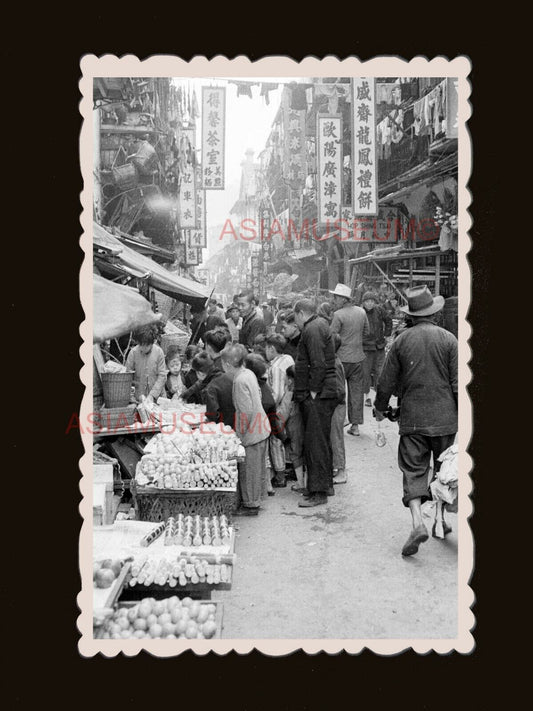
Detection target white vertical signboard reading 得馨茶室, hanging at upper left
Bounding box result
[202,86,226,190]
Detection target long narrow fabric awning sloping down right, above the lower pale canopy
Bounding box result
[93,222,210,306]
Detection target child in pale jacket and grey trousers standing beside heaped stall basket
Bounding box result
[221,343,271,516]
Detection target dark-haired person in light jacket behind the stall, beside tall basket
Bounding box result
[126,326,167,402]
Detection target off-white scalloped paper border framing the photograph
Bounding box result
[77,54,475,657]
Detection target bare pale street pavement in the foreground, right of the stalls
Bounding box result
[213,407,457,639]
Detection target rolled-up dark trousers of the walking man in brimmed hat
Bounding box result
[398,434,455,506]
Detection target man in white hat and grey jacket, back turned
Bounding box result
[330,284,369,436]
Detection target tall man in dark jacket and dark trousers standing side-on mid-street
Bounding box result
[294,299,338,507]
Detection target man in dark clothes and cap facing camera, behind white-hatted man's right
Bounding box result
[363,291,392,407]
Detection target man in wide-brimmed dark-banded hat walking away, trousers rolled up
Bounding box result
[374,285,457,556]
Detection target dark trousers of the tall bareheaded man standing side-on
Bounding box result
[301,395,337,494]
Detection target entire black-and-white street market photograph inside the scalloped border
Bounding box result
[87,76,462,644]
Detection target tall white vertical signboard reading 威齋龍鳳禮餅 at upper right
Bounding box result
[352,77,378,216]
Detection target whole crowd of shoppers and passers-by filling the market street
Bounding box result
[121,284,457,555]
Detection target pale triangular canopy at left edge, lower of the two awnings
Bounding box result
[93,274,161,343]
